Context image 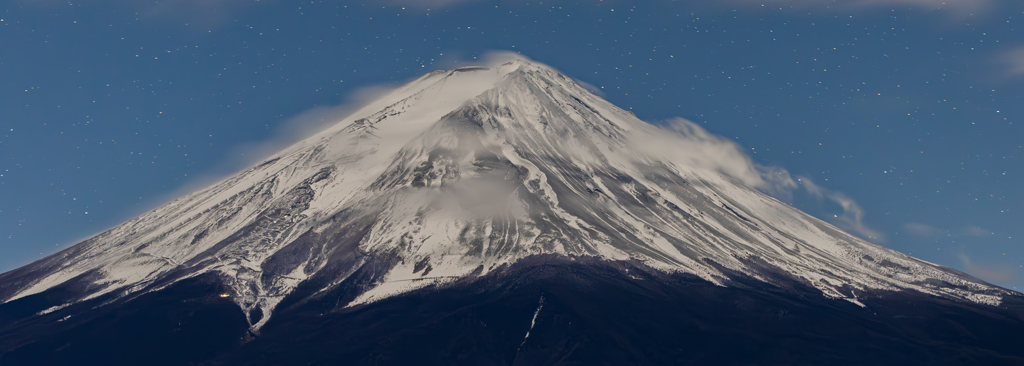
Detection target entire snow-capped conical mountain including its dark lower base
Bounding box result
[0,59,1024,365]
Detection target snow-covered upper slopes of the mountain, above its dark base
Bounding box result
[0,57,1009,330]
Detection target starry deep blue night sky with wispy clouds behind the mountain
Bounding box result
[0,0,1024,288]
